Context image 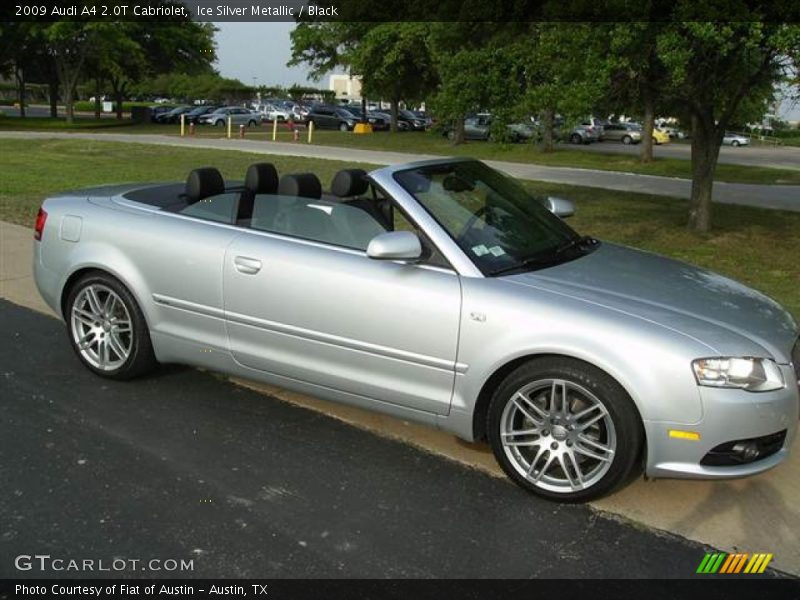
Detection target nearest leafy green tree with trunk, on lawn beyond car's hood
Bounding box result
[656,17,800,233]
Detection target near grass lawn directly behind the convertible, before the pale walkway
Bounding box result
[0,140,800,317]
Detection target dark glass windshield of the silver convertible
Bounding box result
[394,161,585,275]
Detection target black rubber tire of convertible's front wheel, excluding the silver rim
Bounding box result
[487,357,644,503]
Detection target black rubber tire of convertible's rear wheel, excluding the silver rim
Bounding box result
[64,273,156,379]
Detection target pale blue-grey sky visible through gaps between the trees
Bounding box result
[215,22,800,121]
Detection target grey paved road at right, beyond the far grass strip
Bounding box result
[569,142,800,171]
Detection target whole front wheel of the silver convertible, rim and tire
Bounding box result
[487,357,644,503]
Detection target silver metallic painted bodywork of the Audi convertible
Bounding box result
[34,159,800,477]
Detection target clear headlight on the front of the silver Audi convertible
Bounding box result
[692,357,785,392]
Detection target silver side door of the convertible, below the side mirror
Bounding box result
[223,204,461,414]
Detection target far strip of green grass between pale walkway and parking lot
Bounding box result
[0,117,800,185]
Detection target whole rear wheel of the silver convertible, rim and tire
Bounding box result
[64,272,157,379]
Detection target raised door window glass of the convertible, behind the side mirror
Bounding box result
[250,195,386,251]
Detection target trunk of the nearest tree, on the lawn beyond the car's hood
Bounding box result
[689,111,724,233]
